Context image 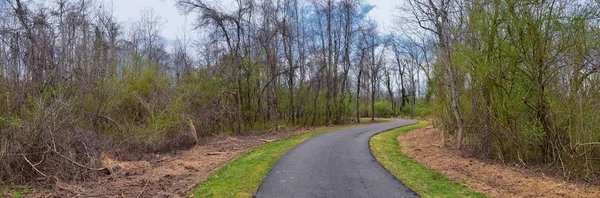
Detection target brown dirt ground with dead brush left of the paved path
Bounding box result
[22,128,332,198]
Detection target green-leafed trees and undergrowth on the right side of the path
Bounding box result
[400,0,600,180]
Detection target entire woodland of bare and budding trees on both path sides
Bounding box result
[0,0,600,184]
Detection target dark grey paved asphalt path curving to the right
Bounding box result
[256,120,418,198]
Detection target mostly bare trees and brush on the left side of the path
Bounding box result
[0,0,432,183]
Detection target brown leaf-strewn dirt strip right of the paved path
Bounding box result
[398,126,600,197]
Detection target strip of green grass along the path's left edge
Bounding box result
[193,120,389,197]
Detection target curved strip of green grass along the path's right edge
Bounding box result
[369,122,486,197]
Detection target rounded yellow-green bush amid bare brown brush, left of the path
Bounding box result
[90,67,191,151]
